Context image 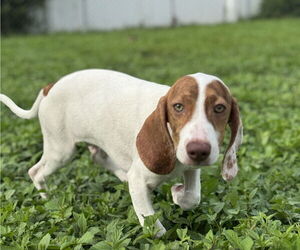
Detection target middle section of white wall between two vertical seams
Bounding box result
[85,0,171,30]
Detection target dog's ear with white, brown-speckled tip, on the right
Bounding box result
[222,98,243,181]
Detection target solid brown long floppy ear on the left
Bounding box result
[136,96,176,175]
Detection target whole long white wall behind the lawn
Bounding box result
[46,0,261,32]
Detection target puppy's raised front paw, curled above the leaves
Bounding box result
[171,184,200,210]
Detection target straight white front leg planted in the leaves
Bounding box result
[127,167,166,237]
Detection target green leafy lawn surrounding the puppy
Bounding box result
[0,19,300,250]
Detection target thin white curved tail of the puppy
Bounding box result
[0,90,44,119]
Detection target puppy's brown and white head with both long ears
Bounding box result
[136,73,243,180]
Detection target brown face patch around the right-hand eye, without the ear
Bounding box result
[204,80,232,143]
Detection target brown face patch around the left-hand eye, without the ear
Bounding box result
[167,76,199,146]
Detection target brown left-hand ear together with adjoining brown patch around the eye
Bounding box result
[136,76,198,174]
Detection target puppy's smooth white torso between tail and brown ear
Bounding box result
[39,70,169,170]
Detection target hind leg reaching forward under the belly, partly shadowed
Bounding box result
[88,145,127,182]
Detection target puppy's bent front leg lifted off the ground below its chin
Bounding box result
[171,169,201,210]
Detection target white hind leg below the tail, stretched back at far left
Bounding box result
[28,138,75,198]
